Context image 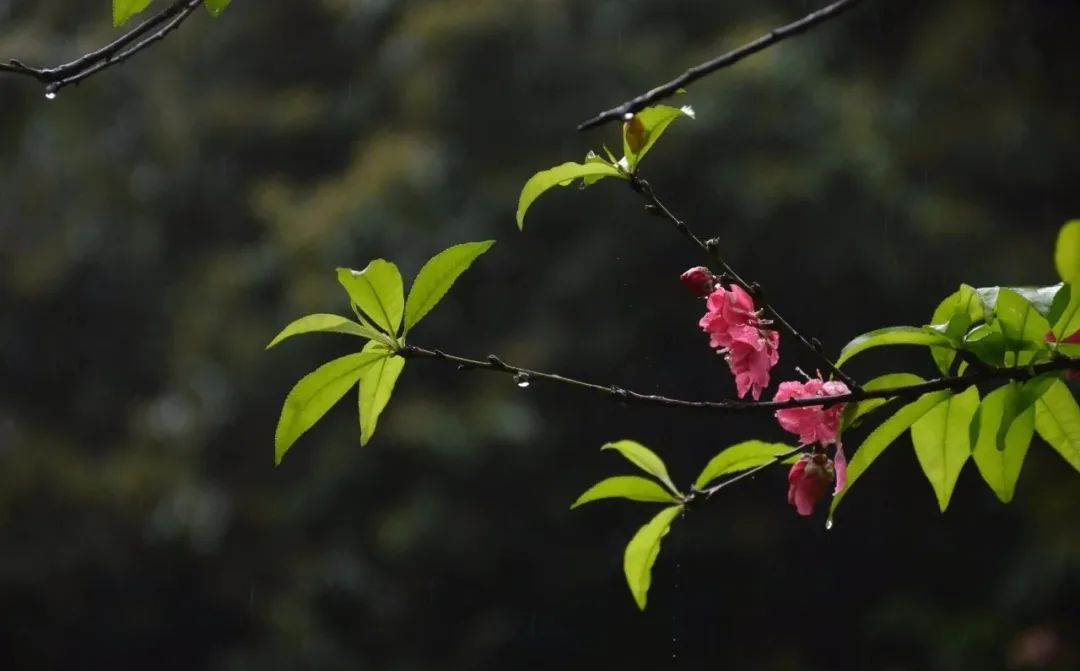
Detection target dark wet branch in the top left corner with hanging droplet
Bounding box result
[0,0,203,97]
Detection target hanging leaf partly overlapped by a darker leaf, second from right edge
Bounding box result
[972,381,1035,504]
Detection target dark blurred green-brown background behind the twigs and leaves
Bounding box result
[0,0,1080,671]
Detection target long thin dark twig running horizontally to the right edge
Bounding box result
[397,345,1080,413]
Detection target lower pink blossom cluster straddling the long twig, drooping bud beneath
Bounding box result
[772,376,850,515]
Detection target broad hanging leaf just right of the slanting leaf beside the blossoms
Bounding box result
[912,386,978,512]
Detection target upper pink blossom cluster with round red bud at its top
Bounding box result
[683,268,780,401]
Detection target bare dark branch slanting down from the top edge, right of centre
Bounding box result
[578,0,862,131]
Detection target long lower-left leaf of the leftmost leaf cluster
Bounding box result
[274,352,382,464]
